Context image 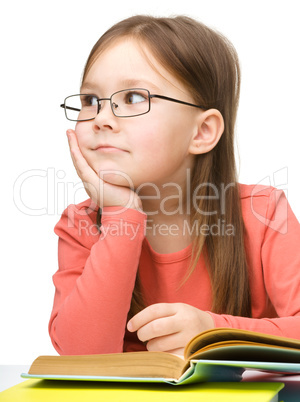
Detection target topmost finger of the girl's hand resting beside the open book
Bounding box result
[127,303,177,332]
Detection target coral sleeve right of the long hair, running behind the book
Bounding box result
[210,189,300,339]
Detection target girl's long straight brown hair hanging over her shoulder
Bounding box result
[83,15,251,317]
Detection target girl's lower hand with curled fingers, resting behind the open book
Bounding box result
[127,303,214,355]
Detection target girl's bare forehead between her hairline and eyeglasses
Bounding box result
[82,38,186,92]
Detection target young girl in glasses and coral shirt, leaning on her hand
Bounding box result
[49,16,300,354]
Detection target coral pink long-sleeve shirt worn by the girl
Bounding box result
[49,184,300,354]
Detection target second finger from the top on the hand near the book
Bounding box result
[137,316,181,342]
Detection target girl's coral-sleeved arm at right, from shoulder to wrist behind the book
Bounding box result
[210,190,300,339]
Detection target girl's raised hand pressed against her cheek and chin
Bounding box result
[67,130,142,210]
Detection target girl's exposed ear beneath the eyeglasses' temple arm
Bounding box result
[189,109,224,155]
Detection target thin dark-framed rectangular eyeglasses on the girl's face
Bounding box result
[60,88,207,121]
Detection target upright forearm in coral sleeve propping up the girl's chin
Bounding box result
[49,206,144,354]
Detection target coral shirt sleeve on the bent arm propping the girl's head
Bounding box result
[49,201,146,355]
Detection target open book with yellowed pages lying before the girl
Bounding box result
[22,328,300,384]
